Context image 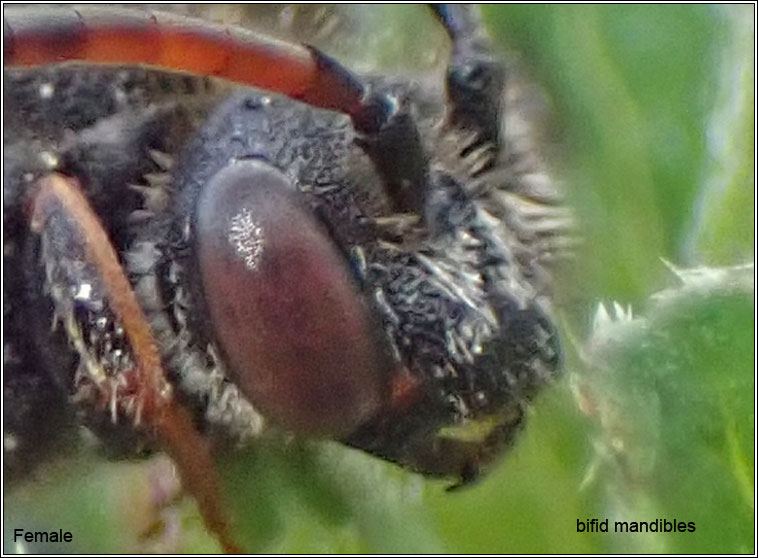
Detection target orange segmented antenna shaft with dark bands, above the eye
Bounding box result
[3,6,365,115]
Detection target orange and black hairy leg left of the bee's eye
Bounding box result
[28,173,237,551]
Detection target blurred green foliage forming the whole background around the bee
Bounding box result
[4,5,755,553]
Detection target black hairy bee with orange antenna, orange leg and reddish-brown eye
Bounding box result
[3,5,569,550]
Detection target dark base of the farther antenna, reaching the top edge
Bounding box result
[430,4,505,150]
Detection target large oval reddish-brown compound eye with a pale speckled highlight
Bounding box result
[195,160,384,437]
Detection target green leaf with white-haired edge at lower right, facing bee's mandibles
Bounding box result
[577,265,755,553]
